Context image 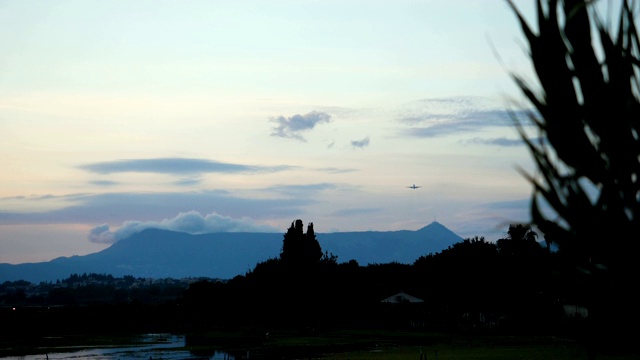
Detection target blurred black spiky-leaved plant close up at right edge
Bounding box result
[508,0,640,354]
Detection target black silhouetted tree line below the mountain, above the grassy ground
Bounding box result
[3,220,596,342]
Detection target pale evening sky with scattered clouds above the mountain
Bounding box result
[0,0,534,264]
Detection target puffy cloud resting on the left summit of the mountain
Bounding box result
[87,211,280,244]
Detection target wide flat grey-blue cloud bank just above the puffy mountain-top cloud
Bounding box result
[0,190,317,225]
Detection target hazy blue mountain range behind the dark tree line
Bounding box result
[0,221,462,283]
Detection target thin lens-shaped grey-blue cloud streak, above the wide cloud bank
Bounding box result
[78,158,291,175]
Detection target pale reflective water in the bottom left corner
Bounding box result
[0,334,235,360]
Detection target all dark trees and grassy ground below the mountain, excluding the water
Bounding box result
[0,220,634,359]
